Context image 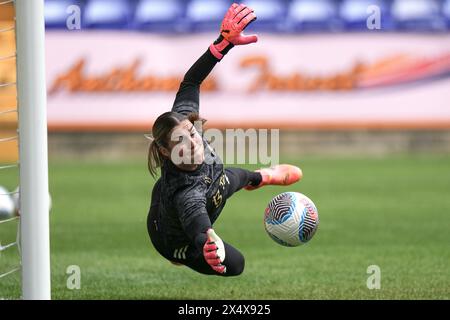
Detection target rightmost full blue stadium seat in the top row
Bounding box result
[391,0,446,31]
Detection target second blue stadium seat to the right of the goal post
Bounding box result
[82,0,135,29]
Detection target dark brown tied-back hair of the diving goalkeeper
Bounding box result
[147,111,206,178]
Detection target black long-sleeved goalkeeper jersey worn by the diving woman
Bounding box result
[154,50,229,247]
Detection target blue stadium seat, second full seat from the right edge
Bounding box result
[339,0,393,31]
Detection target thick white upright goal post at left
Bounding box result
[15,0,51,300]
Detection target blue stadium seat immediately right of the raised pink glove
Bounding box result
[244,0,287,33]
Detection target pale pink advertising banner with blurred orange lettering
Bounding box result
[46,31,450,131]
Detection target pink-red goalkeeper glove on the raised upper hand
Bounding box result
[209,3,258,60]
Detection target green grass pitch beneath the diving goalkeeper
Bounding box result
[0,155,450,299]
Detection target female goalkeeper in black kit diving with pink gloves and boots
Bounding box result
[147,4,302,276]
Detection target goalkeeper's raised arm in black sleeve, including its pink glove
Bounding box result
[172,3,258,115]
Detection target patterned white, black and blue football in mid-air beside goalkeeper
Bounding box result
[264,192,319,247]
